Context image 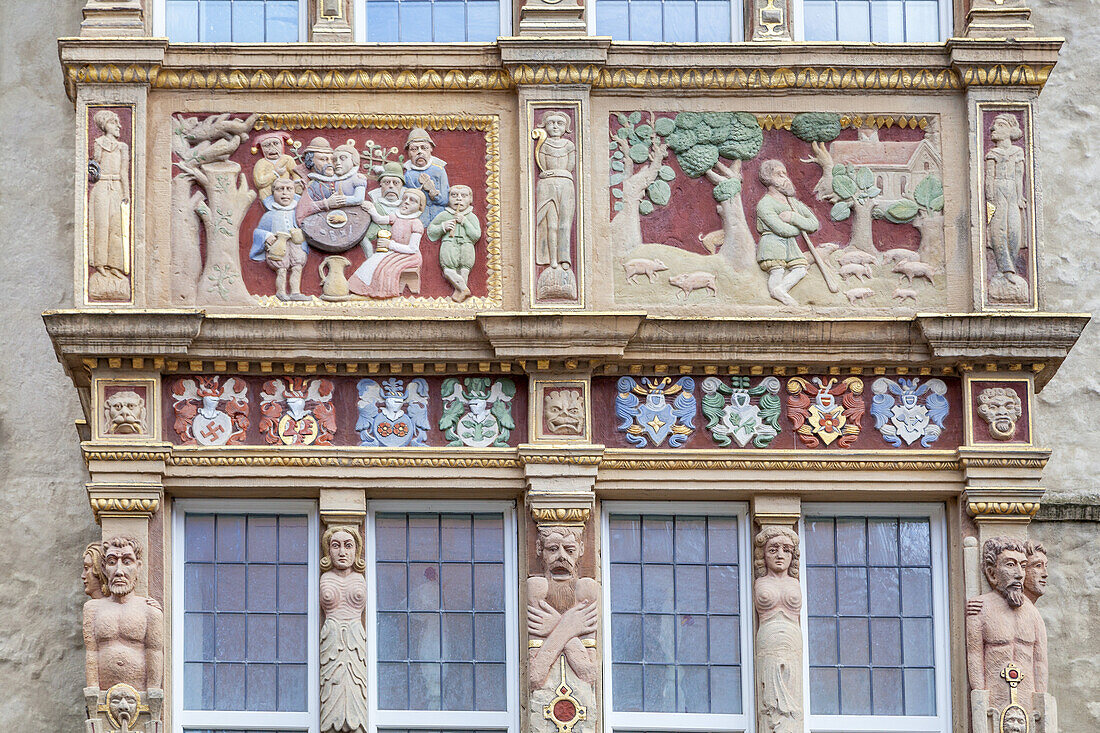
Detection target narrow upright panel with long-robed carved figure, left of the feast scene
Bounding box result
[84,106,134,304]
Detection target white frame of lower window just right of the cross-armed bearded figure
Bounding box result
[601,501,756,733]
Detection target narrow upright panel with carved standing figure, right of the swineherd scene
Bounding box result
[978,105,1037,308]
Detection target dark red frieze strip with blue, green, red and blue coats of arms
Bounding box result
[592,368,965,451]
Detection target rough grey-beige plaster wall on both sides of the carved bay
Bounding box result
[0,0,1100,733]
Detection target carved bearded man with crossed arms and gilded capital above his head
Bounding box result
[527,505,600,733]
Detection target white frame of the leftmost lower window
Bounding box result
[172,499,321,733]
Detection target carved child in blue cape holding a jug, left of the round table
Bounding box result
[249,178,310,300]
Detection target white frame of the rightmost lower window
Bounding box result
[799,502,952,733]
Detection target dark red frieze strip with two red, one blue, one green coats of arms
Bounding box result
[163,374,528,448]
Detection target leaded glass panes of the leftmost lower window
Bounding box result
[184,513,309,711]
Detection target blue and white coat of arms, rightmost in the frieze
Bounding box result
[871,376,949,448]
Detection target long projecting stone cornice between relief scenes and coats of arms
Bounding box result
[43,309,1089,387]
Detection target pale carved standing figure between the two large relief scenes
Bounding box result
[535,110,576,270]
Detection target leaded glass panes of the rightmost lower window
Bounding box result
[806,517,936,715]
